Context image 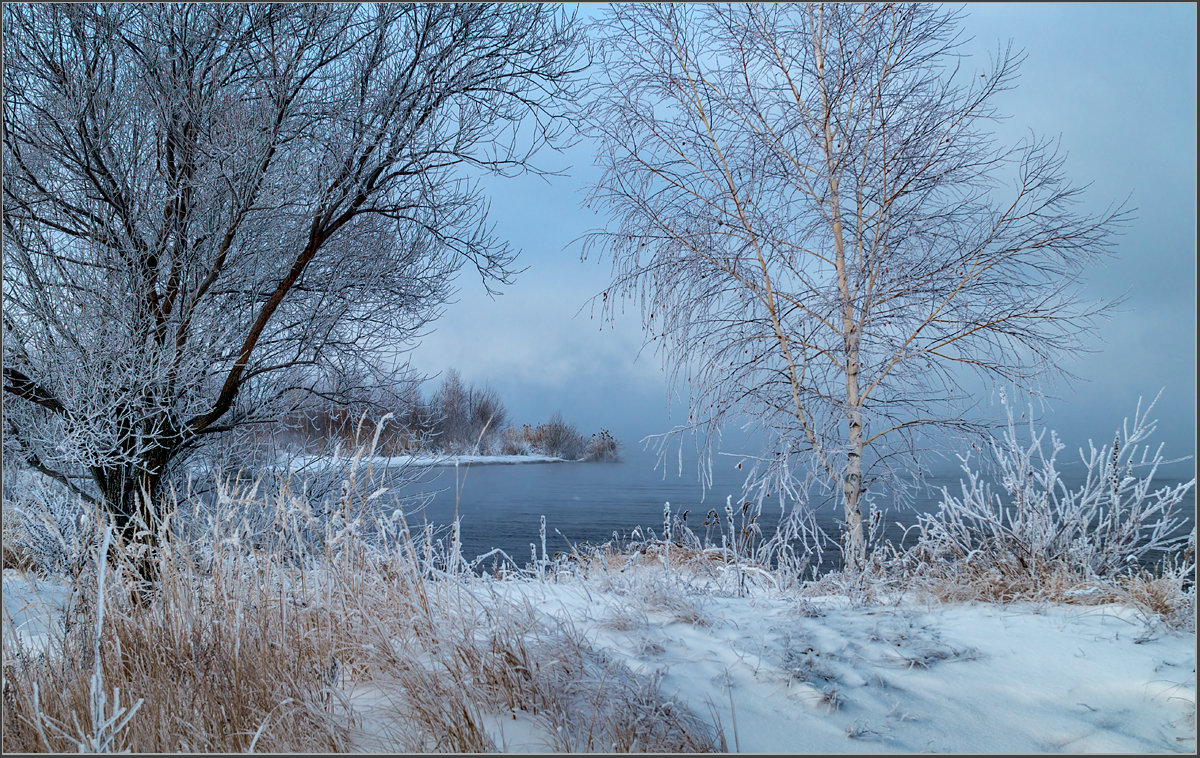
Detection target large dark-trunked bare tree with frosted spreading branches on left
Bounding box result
[4,4,578,544]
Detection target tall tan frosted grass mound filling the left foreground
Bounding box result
[2,474,725,752]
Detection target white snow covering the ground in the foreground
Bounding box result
[4,565,1196,753]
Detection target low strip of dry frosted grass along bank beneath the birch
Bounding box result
[550,522,1196,631]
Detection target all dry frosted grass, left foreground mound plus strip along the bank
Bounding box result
[2,426,1195,753]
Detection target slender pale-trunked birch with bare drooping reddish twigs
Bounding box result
[584,4,1123,566]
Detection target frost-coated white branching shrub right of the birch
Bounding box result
[905,396,1195,594]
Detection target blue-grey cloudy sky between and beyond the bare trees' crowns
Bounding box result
[412,4,1196,468]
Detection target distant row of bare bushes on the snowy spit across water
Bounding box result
[284,368,619,461]
